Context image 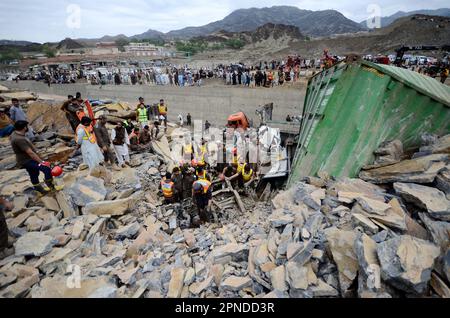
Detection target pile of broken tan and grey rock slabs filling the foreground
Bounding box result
[0,132,450,298]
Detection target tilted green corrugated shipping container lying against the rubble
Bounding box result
[288,61,450,185]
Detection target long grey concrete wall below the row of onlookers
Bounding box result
[4,81,305,125]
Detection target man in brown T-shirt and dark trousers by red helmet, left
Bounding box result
[11,120,61,195]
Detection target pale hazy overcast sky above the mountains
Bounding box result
[0,0,450,42]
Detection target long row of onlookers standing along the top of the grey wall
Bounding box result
[18,56,320,87]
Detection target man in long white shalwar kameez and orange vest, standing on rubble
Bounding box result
[76,117,104,172]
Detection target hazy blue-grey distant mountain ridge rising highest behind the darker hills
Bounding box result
[166,6,365,38]
